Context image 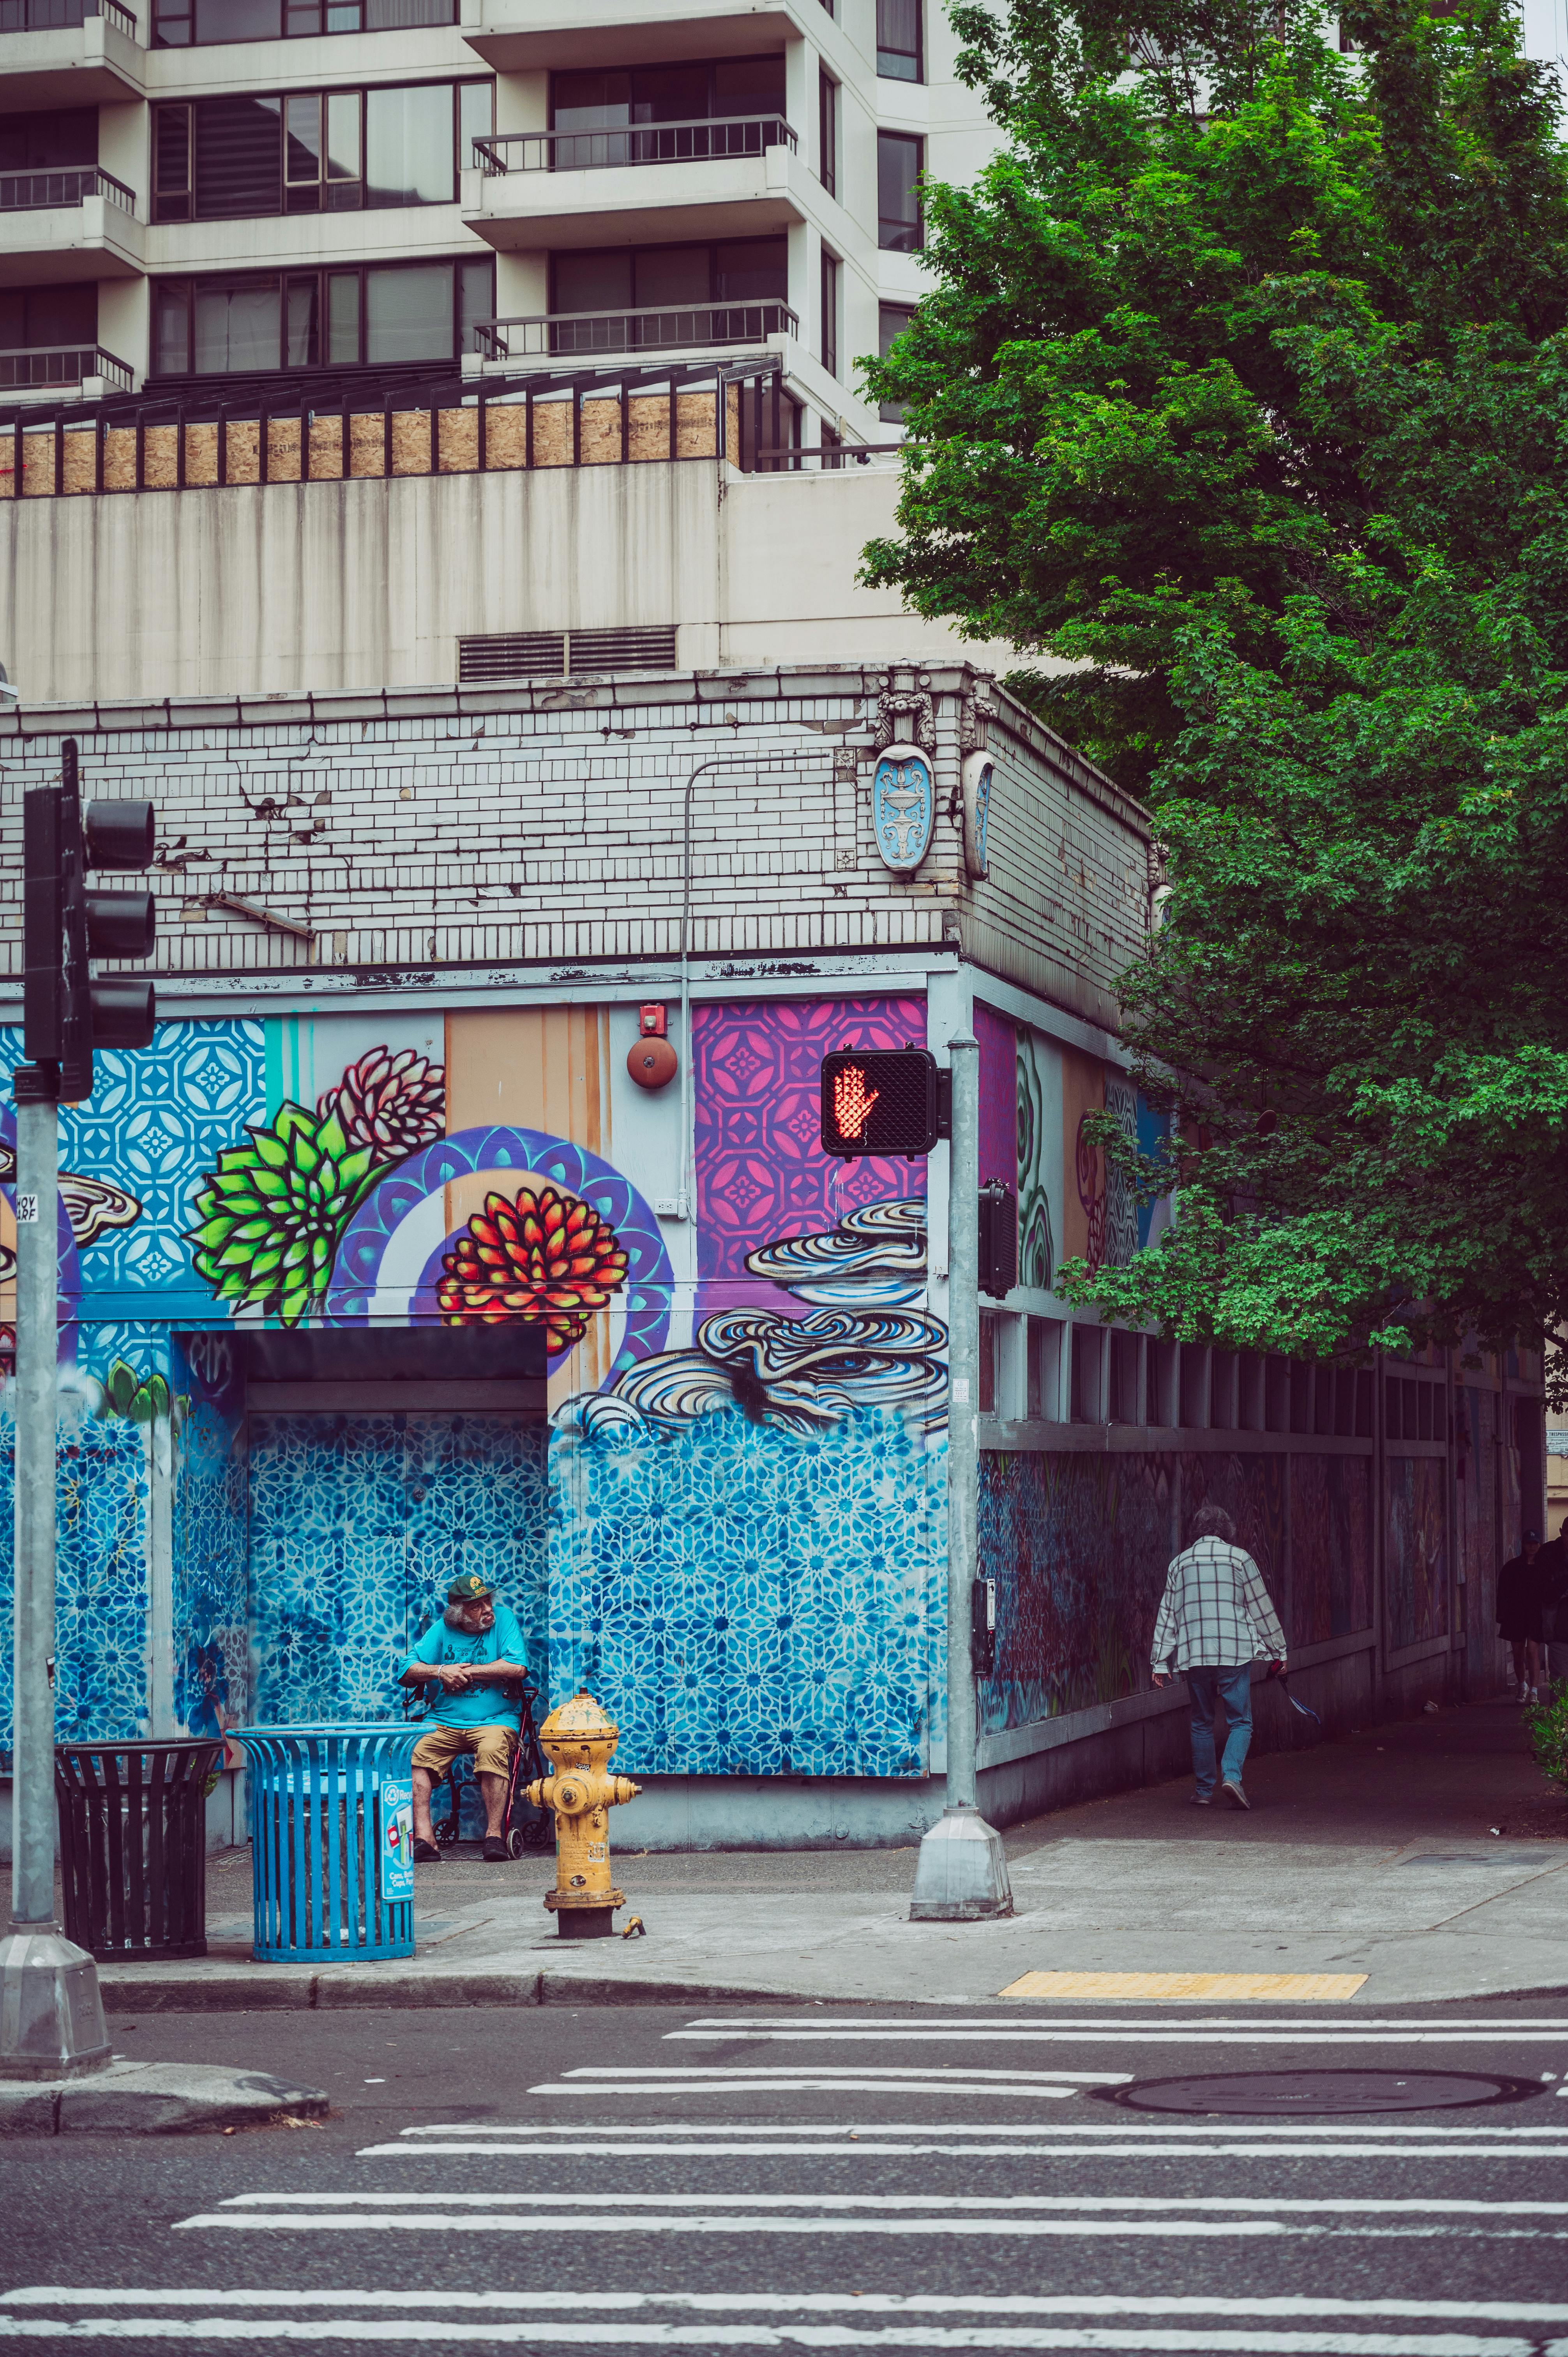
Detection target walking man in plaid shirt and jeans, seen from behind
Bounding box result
[1153,1506,1285,1808]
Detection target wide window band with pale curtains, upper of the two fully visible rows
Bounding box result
[153,78,495,222]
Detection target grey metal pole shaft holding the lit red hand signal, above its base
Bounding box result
[948,1032,981,1808]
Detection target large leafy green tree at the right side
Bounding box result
[865,0,1568,1353]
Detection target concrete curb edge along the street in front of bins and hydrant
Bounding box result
[99,1970,821,2013]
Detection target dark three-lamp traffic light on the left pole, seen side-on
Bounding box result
[21,738,158,1106]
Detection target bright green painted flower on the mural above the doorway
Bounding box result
[186,1106,380,1325]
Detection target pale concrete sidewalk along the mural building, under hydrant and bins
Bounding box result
[18,1702,1568,2013]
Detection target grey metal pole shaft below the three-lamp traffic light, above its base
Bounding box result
[12,1103,59,1928]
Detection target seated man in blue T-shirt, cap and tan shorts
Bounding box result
[399,1572,528,1864]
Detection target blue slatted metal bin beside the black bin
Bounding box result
[233,1725,422,1963]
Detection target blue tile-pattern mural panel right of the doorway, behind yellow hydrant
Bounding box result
[549,1407,946,1777]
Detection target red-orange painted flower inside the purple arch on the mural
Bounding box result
[436,1186,627,1351]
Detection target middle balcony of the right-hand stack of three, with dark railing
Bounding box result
[462,115,806,250]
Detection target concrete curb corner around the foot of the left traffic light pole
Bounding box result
[0,2060,328,2135]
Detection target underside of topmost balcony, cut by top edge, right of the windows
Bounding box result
[462,0,797,73]
